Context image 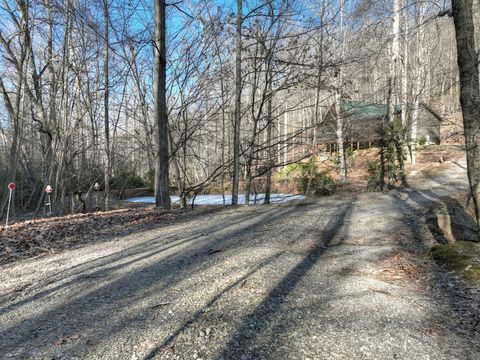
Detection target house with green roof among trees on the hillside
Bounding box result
[317,99,441,151]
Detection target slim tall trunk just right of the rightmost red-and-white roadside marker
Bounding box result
[103,0,112,211]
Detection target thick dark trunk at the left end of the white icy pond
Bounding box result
[153,0,170,210]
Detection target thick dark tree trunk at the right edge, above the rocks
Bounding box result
[452,0,480,236]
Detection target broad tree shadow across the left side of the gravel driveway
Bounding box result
[0,202,308,353]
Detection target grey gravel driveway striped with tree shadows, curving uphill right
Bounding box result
[0,156,480,360]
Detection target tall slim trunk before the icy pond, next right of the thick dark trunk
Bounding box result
[232,0,243,205]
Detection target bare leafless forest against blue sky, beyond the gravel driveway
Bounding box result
[0,0,478,214]
